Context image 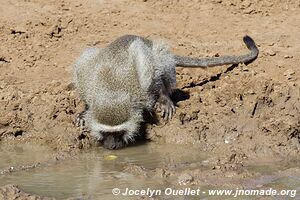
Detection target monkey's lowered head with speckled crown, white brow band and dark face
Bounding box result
[87,90,144,149]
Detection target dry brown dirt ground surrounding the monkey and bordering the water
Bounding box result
[0,0,300,199]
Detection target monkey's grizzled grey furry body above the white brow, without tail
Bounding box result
[74,35,175,125]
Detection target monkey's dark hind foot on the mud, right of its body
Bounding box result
[155,95,176,120]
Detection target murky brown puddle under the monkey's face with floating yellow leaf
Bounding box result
[0,145,203,199]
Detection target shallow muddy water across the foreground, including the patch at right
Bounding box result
[0,144,300,199]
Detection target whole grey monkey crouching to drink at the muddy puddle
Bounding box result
[73,35,259,149]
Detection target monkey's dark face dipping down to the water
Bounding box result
[101,131,126,149]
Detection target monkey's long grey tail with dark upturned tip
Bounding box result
[174,35,259,67]
